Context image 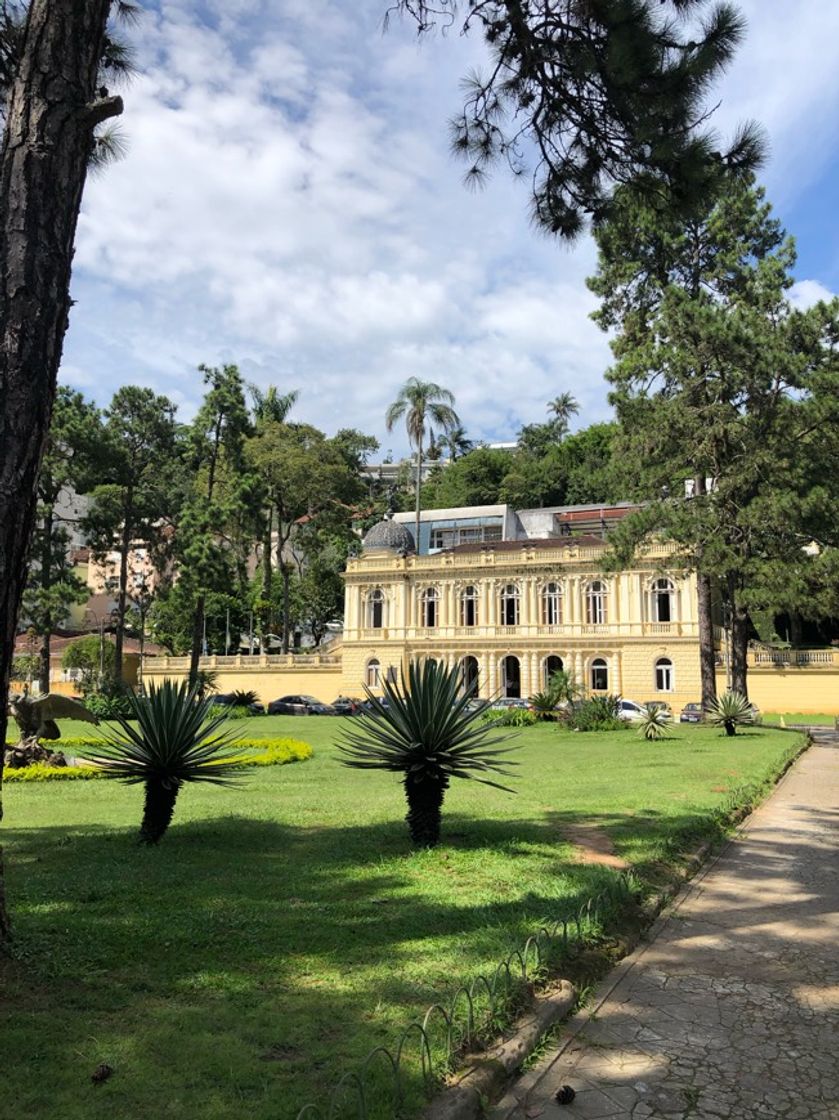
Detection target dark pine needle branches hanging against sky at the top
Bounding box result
[390,0,765,241]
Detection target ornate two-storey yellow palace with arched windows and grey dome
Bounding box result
[342,505,700,709]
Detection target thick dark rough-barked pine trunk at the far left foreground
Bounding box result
[0,0,122,951]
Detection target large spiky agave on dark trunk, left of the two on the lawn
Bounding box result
[91,681,241,843]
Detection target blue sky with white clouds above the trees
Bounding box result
[60,0,839,455]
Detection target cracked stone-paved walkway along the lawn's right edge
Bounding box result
[490,729,839,1120]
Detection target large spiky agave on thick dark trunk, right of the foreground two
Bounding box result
[338,661,515,848]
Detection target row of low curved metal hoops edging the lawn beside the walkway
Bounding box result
[296,871,633,1120]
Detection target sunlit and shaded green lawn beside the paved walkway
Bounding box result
[0,717,796,1120]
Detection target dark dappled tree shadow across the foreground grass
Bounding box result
[7,788,819,1120]
